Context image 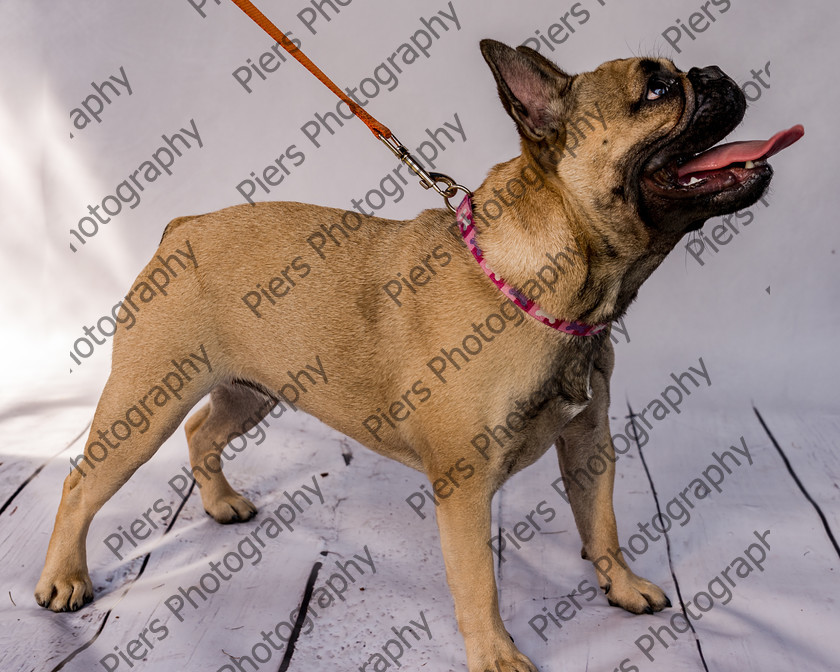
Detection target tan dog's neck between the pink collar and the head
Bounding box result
[473,155,671,324]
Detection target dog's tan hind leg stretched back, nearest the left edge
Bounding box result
[35,356,216,611]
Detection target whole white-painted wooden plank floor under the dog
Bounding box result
[0,386,840,672]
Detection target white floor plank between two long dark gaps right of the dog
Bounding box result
[638,404,840,672]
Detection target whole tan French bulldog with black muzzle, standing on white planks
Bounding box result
[35,40,801,672]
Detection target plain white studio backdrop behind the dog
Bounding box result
[0,0,840,669]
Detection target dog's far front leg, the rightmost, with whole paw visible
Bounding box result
[557,366,671,614]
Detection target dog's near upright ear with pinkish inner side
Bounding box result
[481,40,572,143]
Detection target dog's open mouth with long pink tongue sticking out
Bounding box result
[646,125,805,196]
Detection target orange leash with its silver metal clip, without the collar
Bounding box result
[226,0,471,212]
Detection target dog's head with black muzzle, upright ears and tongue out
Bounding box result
[481,40,802,239]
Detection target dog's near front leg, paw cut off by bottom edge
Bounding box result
[430,470,537,672]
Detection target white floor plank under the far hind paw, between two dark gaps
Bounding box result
[50,410,343,670]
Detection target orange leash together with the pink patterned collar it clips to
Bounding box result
[226,0,608,336]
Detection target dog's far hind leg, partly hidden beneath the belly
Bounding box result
[186,383,274,523]
